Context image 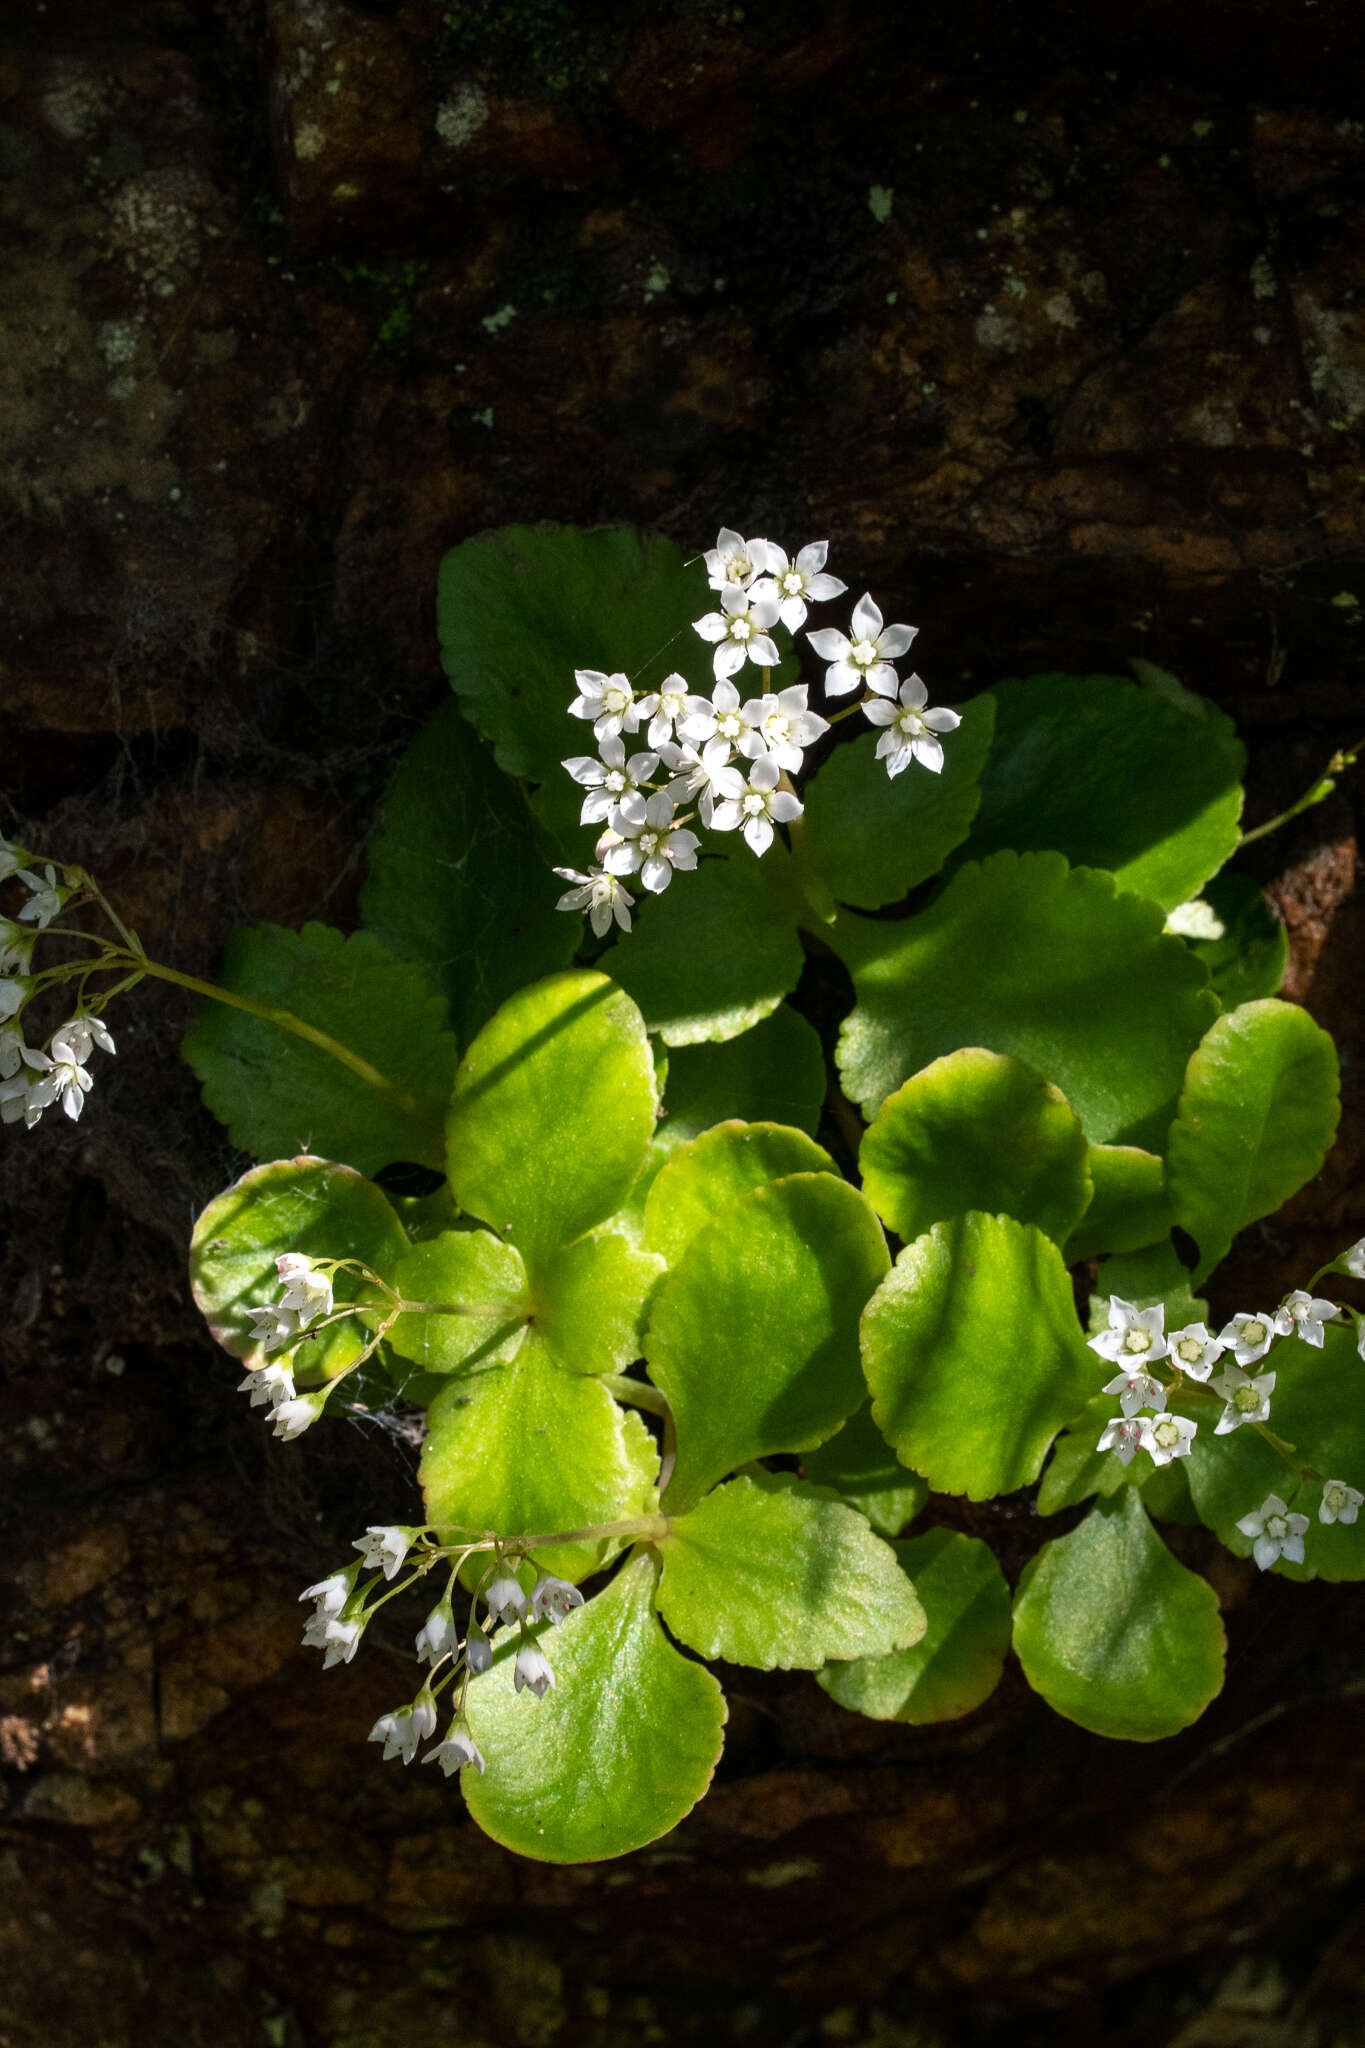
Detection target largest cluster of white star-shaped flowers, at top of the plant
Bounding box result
[555,526,960,938]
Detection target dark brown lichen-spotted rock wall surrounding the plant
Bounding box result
[0,0,1365,2048]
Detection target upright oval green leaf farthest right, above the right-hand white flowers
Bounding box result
[1166,997,1340,1280]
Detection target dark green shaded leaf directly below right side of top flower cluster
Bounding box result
[806,696,995,909]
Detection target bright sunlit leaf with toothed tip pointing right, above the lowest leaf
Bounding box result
[659,1473,925,1671]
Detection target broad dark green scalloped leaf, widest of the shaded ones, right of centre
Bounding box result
[829,854,1216,1145]
